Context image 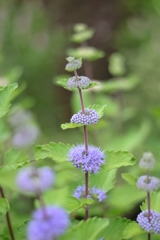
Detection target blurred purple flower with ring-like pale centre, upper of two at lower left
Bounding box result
[16,167,54,193]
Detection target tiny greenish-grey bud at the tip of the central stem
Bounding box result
[65,57,82,72]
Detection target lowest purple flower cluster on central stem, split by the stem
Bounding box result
[73,186,107,202]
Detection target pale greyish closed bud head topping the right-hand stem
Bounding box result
[139,152,155,170]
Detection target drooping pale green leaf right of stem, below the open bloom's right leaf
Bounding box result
[89,169,117,192]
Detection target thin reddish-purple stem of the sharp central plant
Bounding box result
[74,71,89,220]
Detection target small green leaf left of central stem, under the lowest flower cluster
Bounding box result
[64,196,94,213]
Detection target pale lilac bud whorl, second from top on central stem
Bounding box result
[67,76,91,90]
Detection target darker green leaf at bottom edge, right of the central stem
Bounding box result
[97,217,130,240]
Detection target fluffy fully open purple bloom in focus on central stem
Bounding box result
[68,144,105,173]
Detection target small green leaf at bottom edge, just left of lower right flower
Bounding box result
[123,221,145,239]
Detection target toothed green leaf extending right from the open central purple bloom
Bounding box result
[102,150,136,171]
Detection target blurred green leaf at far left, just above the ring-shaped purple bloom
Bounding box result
[2,149,29,172]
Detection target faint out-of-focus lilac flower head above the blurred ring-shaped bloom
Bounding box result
[11,124,40,148]
